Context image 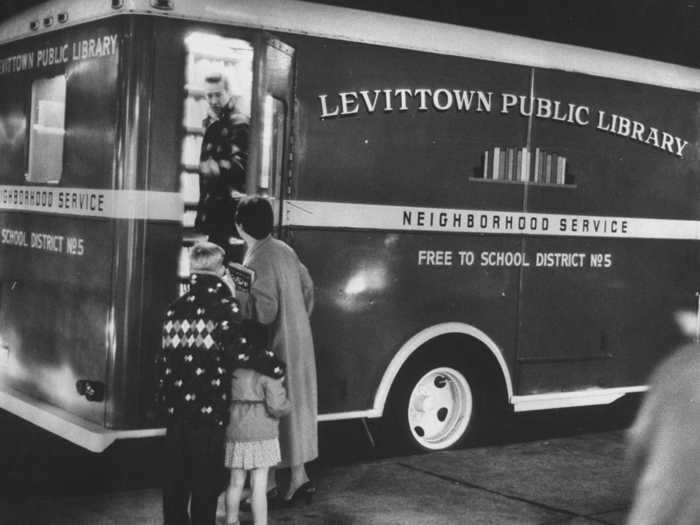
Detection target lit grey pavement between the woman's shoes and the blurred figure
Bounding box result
[274,432,627,525]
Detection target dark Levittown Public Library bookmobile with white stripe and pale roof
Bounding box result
[0,0,700,452]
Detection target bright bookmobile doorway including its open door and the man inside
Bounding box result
[179,31,294,278]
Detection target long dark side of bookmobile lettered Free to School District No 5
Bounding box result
[282,38,698,413]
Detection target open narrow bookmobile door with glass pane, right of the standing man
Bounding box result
[246,36,294,226]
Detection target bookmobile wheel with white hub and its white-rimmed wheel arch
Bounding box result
[377,332,510,450]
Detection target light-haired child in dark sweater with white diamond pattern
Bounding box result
[156,242,245,525]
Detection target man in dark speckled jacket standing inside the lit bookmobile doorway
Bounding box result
[195,73,250,260]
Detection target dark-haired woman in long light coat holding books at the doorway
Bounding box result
[235,197,318,503]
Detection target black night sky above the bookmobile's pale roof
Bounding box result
[0,0,700,67]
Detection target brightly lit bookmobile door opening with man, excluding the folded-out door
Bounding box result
[180,31,254,270]
